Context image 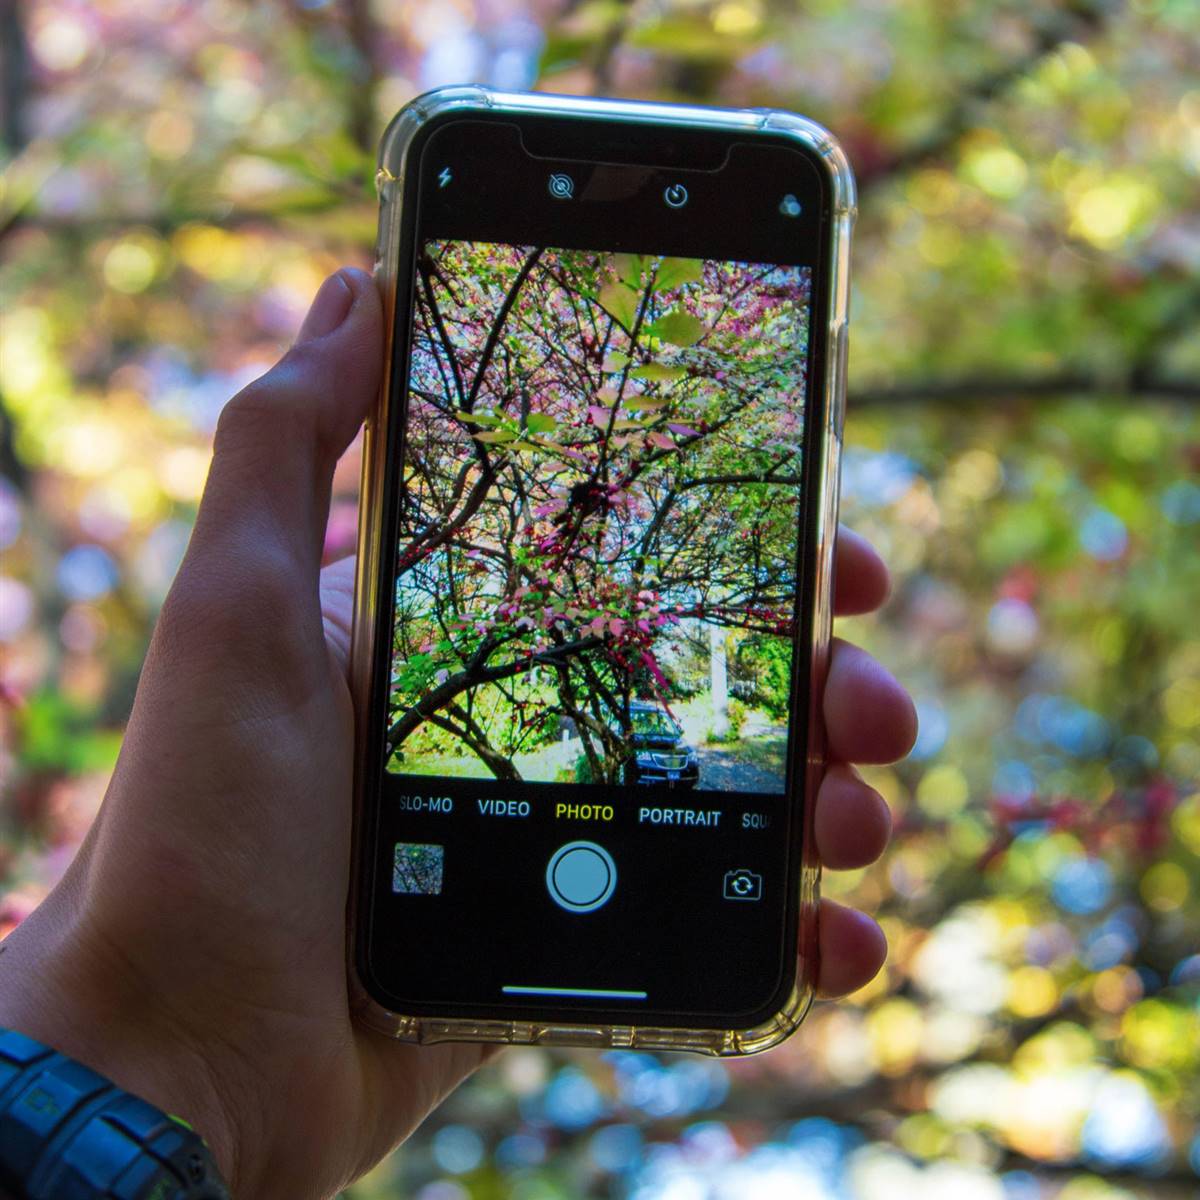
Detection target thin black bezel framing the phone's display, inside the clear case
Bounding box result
[353,110,834,1030]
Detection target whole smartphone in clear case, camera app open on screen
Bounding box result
[349,86,854,1054]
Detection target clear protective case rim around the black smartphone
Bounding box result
[347,85,856,1055]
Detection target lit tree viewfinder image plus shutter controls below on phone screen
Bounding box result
[374,239,811,1024]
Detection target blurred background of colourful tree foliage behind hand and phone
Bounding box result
[0,0,1200,1200]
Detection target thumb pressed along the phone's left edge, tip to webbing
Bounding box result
[188,269,383,576]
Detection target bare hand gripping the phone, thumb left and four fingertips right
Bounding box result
[0,270,916,1200]
